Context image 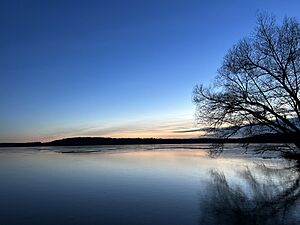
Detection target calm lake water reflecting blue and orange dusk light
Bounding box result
[0,145,300,225]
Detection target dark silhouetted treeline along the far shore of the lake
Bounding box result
[0,134,300,147]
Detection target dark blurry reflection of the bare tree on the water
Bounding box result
[199,161,300,225]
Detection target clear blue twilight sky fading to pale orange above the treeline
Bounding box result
[0,0,300,142]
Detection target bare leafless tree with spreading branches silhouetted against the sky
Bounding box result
[193,14,300,147]
